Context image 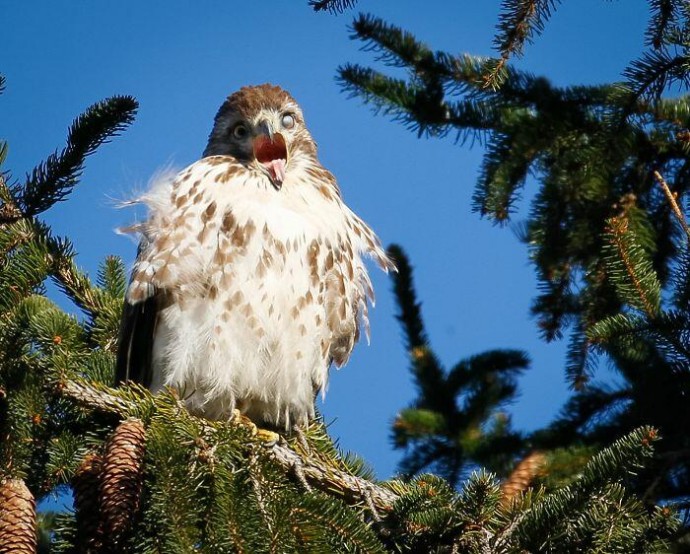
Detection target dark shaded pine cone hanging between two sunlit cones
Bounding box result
[72,453,103,553]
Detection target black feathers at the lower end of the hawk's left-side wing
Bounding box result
[115,294,160,387]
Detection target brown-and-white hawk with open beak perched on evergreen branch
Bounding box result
[116,84,394,428]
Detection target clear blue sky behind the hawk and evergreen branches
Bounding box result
[0,0,648,478]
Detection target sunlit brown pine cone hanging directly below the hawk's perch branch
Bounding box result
[100,418,146,545]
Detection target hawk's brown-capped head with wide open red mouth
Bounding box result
[204,84,316,189]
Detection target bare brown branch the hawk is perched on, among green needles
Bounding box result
[58,380,398,517]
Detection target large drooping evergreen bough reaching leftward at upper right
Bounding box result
[339,10,690,366]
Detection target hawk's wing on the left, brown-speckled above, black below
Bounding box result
[115,156,242,386]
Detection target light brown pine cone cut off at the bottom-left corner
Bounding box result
[0,479,36,554]
